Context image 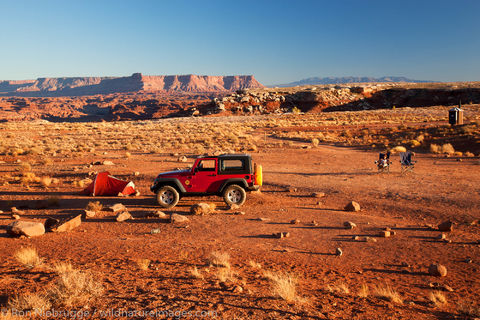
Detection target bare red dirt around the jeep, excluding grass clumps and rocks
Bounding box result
[0,124,480,319]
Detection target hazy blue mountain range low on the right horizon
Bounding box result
[272,77,433,87]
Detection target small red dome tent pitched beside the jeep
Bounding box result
[82,172,137,196]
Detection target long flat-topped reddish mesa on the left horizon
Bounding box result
[0,73,264,97]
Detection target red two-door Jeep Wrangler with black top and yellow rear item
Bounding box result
[150,154,262,208]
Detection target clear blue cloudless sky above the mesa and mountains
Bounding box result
[0,0,480,85]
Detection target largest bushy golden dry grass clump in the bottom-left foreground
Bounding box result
[48,269,103,307]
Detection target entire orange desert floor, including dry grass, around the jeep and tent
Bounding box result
[0,104,480,319]
